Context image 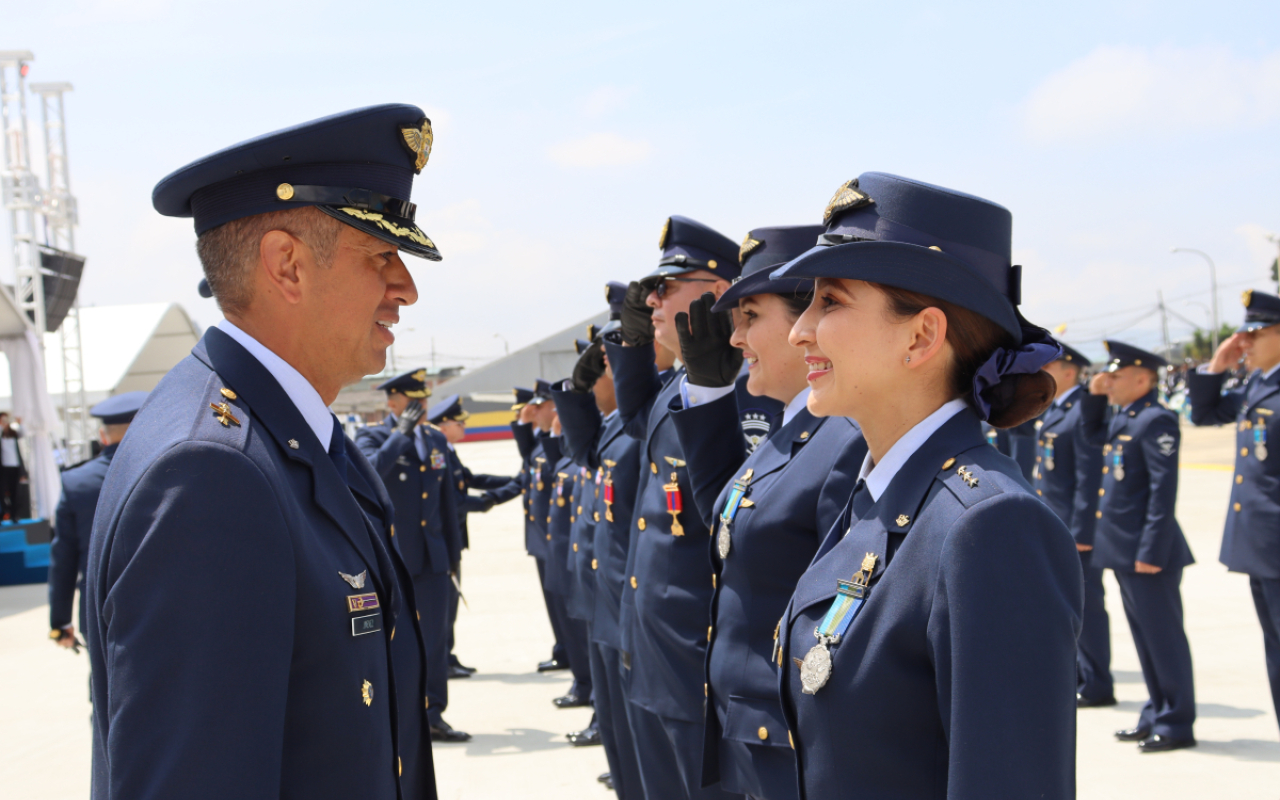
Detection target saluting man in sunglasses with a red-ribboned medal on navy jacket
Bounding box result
[605,216,781,797]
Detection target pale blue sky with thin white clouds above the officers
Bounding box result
[0,0,1280,366]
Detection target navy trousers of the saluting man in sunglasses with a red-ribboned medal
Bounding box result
[627,703,742,800]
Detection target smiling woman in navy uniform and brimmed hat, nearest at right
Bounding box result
[762,173,1083,800]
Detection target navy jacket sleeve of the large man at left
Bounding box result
[91,443,297,800]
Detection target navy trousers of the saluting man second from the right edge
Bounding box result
[1115,567,1196,739]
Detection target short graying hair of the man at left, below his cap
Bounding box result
[196,207,342,314]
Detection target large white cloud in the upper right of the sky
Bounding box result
[1023,46,1280,142]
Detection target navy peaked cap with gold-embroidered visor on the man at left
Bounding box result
[151,104,440,261]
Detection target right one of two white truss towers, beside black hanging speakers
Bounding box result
[31,82,91,463]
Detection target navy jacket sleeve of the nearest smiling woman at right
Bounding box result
[931,493,1084,800]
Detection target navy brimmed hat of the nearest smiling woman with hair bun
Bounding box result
[773,173,1023,344]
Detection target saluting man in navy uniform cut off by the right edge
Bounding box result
[1187,291,1280,719]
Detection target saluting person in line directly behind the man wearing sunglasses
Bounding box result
[552,282,650,800]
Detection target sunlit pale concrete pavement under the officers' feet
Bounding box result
[0,429,1280,800]
